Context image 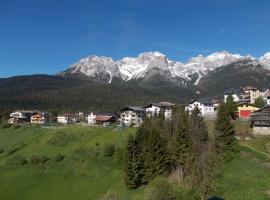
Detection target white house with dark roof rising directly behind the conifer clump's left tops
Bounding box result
[145,102,175,119]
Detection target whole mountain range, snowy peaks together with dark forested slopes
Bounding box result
[0,51,270,111]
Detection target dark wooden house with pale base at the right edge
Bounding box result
[250,102,270,135]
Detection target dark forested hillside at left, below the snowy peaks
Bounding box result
[0,75,184,111]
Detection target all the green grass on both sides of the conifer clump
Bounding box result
[0,126,270,200]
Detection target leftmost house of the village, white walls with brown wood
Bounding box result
[8,110,36,124]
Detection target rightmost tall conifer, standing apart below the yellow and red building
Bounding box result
[215,103,235,159]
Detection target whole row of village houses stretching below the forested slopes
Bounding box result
[5,86,270,135]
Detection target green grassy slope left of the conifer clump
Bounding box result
[0,127,143,199]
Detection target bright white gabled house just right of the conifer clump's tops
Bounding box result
[186,100,216,117]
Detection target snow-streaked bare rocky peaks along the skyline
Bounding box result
[59,51,270,86]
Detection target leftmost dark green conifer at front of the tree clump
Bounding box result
[125,136,143,189]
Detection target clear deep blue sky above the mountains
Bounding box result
[0,0,270,78]
